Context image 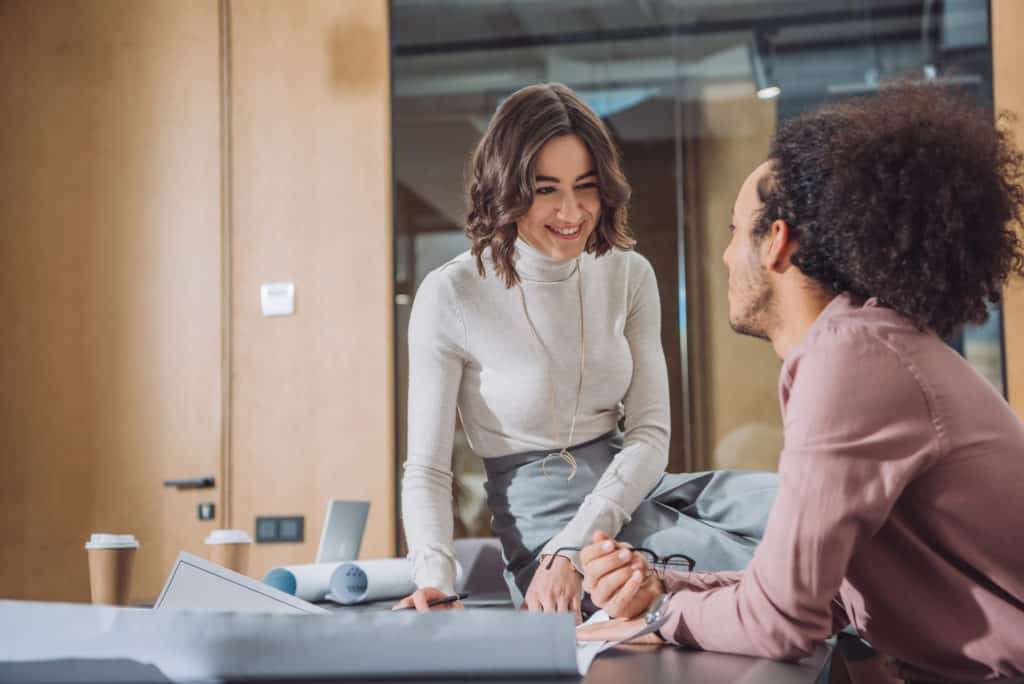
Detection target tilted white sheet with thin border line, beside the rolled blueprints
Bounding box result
[153,551,328,614]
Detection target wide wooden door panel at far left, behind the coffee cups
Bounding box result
[0,0,220,601]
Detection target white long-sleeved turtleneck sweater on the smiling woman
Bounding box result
[401,240,670,593]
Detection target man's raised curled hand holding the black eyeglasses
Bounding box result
[580,531,665,622]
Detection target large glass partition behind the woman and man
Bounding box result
[391,0,1004,536]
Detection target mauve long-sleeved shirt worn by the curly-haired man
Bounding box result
[662,295,1024,681]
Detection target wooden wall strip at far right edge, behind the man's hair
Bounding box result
[991,0,1024,418]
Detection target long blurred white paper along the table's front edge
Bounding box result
[0,601,589,682]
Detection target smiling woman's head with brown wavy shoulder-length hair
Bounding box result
[466,83,635,286]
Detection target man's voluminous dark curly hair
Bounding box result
[754,83,1024,337]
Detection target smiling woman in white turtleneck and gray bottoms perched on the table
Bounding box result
[393,84,775,616]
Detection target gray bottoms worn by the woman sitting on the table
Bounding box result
[483,432,777,606]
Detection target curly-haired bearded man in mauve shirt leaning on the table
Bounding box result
[582,84,1024,682]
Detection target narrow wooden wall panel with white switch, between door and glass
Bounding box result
[230,0,395,575]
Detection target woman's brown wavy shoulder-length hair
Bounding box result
[466,83,636,288]
